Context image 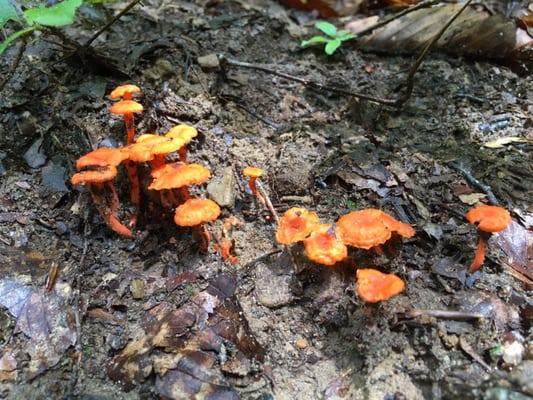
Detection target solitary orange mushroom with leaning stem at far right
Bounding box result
[466,204,511,273]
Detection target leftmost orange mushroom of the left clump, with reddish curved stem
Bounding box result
[71,165,132,237]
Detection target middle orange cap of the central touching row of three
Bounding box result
[304,224,348,265]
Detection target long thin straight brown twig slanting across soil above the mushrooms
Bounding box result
[218,54,396,106]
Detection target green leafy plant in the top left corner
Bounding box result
[0,0,83,55]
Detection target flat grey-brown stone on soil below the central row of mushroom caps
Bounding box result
[255,264,293,308]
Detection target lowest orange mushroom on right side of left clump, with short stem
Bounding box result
[174,199,220,251]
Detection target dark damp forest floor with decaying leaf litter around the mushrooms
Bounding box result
[0,2,533,399]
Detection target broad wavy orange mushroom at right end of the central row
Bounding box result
[337,208,415,250]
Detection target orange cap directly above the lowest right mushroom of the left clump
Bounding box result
[148,162,211,190]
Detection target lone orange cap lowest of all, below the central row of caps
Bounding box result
[357,268,405,303]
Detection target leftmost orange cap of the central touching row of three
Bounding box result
[276,207,319,244]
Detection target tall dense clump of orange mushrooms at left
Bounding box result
[71,85,220,248]
